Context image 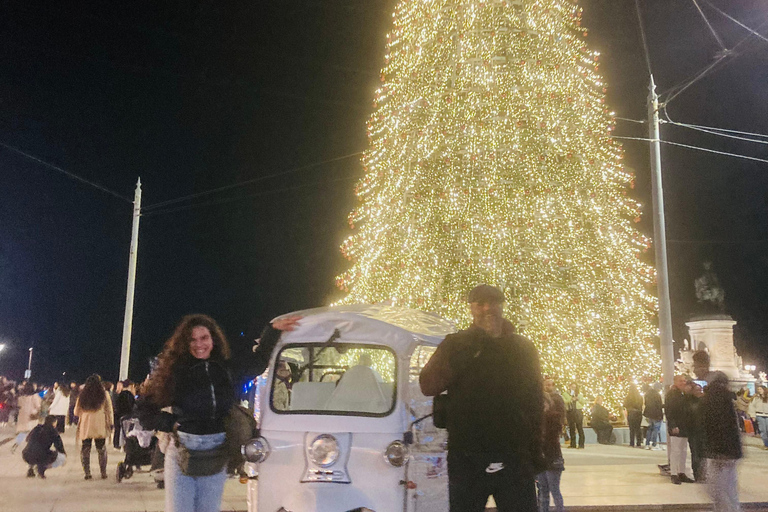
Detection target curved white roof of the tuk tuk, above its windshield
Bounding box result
[275,304,456,353]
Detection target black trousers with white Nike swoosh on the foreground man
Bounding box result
[448,451,537,512]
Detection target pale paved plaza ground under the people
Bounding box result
[0,428,768,512]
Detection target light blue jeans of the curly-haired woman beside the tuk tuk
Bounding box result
[163,432,227,512]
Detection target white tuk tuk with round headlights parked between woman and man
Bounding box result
[243,305,456,512]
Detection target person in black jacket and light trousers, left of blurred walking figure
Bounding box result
[664,375,694,485]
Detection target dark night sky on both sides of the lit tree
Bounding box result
[0,0,768,381]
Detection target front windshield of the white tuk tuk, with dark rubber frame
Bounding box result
[270,343,397,416]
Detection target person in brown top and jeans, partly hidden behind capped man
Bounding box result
[536,378,565,512]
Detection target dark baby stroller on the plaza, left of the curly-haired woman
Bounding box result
[116,415,165,489]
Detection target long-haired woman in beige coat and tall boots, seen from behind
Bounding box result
[75,374,114,480]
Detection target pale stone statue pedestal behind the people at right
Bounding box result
[685,315,742,380]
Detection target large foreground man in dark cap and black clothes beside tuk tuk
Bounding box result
[419,285,544,512]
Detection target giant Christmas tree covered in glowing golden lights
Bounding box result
[337,0,660,409]
